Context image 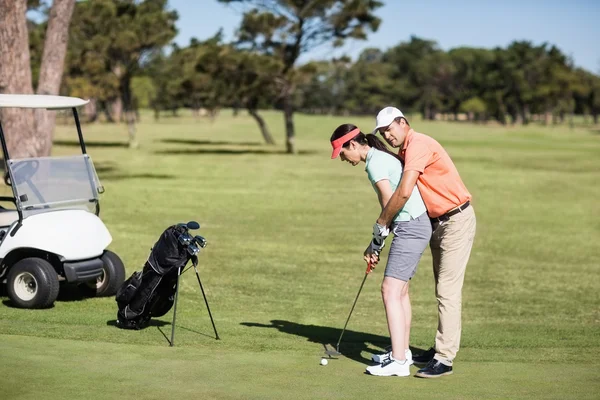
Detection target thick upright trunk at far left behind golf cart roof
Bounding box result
[0,0,39,158]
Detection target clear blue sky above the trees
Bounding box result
[169,0,600,74]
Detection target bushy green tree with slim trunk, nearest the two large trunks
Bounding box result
[70,0,177,147]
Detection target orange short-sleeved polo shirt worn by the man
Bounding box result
[398,129,471,218]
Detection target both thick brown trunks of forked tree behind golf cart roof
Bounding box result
[0,0,75,158]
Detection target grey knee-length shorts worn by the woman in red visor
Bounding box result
[385,213,431,282]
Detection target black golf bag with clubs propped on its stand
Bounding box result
[116,225,196,329]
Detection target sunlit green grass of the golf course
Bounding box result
[0,111,600,399]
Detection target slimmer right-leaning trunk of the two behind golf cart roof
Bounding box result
[34,0,75,156]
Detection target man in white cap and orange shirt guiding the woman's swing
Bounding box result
[365,107,476,378]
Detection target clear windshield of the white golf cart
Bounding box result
[8,154,103,218]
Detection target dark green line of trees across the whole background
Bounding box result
[0,0,600,157]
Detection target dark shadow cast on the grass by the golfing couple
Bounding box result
[241,320,423,365]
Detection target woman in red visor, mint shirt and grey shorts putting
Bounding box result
[330,124,431,376]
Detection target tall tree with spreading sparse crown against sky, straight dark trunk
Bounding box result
[219,0,382,153]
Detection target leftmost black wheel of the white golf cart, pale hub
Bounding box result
[6,257,59,308]
